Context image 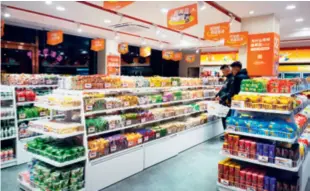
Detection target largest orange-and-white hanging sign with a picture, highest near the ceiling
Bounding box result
[167,3,198,30]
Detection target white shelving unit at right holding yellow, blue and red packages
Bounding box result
[217,90,309,191]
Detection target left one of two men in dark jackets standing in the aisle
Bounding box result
[216,64,233,140]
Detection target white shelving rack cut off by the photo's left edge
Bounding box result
[0,86,18,168]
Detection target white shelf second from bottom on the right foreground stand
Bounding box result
[220,151,303,172]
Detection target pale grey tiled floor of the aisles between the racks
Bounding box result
[1,139,310,191]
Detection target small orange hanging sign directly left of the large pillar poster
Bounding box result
[224,32,249,47]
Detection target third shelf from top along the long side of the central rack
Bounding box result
[87,110,207,137]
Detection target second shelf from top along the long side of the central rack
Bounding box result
[85,96,215,116]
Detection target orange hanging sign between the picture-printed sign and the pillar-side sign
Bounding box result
[204,22,230,41]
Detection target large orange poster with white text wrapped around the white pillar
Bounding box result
[247,33,280,76]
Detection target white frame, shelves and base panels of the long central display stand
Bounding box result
[17,86,223,190]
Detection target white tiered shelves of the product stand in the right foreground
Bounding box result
[217,91,310,191]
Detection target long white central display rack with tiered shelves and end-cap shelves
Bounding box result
[19,86,223,191]
